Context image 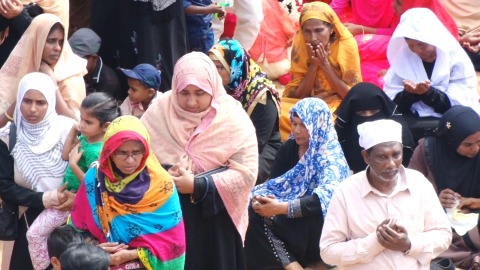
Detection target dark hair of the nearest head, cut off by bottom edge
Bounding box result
[60,243,110,270]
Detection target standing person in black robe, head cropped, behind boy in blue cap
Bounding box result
[91,0,188,94]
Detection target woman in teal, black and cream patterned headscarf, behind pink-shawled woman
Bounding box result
[208,39,282,185]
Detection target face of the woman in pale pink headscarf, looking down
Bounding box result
[177,84,212,113]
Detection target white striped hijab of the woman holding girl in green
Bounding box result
[12,72,73,190]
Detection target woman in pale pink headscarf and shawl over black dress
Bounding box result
[142,52,258,270]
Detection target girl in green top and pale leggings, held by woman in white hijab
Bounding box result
[27,92,121,270]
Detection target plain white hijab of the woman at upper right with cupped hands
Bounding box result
[384,8,480,117]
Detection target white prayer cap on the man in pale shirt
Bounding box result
[357,119,402,150]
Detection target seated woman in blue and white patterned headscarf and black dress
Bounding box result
[245,98,349,269]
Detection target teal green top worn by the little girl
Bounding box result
[62,135,103,192]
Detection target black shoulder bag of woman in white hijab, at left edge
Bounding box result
[0,124,18,241]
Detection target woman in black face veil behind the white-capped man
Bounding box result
[335,82,415,173]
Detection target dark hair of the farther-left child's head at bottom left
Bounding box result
[47,225,83,258]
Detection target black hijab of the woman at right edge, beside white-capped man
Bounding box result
[425,105,480,198]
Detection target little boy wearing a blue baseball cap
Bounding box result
[120,64,161,118]
